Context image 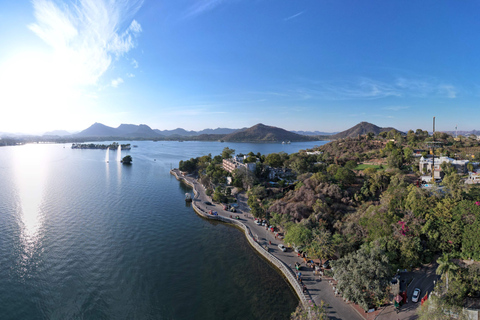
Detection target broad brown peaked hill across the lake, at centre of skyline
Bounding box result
[223,123,314,142]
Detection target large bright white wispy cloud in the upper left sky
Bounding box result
[28,0,143,85]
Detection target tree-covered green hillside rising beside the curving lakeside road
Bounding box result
[179,129,480,319]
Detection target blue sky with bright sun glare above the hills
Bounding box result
[0,0,480,134]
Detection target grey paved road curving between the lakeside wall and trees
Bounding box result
[179,171,364,320]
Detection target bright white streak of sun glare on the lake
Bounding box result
[14,145,48,273]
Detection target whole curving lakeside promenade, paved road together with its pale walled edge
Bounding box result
[171,169,362,320]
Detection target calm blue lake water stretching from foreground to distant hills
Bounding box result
[0,141,325,319]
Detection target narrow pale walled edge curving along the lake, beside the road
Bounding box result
[170,169,315,309]
